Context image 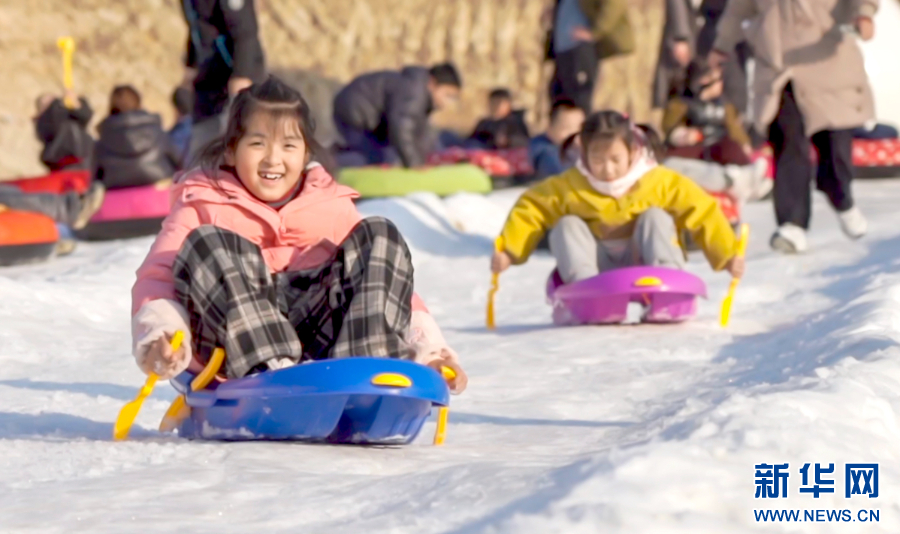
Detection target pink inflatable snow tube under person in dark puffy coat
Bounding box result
[77,180,172,241]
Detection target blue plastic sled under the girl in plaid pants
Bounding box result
[172,358,449,444]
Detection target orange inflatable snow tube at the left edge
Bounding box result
[0,206,59,266]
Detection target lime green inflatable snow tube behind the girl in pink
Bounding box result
[338,165,493,198]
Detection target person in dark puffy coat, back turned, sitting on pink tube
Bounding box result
[94,85,181,189]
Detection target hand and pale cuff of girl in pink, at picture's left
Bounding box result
[131,299,192,380]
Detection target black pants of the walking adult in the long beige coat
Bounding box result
[769,84,853,229]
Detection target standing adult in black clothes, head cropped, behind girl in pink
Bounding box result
[182,0,265,161]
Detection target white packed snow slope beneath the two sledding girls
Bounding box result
[0,182,900,534]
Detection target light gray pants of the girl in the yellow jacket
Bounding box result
[549,208,685,284]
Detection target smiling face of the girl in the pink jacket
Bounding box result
[225,112,309,202]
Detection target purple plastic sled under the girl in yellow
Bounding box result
[547,267,706,325]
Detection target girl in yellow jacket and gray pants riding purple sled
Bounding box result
[491,111,744,283]
